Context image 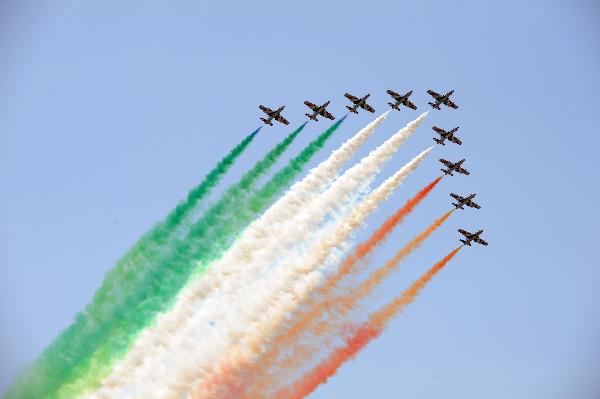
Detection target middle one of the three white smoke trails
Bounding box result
[129,114,426,397]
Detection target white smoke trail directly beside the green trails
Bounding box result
[91,112,388,397]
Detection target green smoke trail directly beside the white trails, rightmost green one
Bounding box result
[60,119,343,398]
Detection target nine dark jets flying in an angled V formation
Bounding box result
[259,89,488,246]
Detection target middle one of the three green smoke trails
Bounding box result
[27,125,305,397]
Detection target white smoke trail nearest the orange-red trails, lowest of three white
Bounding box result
[196,147,432,397]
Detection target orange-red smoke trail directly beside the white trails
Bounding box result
[240,177,450,396]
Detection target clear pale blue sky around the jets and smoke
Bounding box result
[0,0,600,399]
